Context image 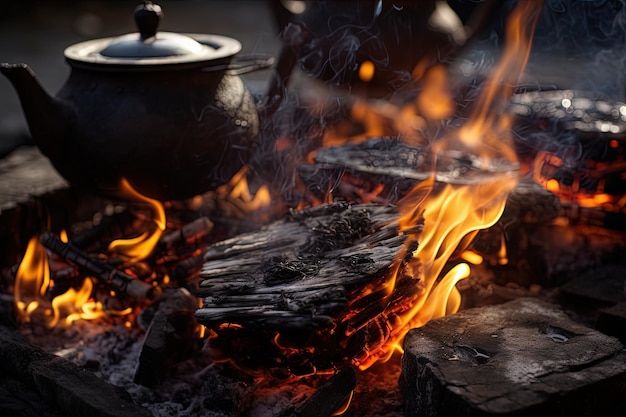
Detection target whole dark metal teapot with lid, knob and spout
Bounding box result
[0,2,270,201]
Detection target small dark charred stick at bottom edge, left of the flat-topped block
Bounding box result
[296,368,356,417]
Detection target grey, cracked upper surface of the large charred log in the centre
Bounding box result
[196,204,406,329]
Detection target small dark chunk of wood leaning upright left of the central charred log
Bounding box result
[134,288,199,387]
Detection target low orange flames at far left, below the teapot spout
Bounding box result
[14,237,104,328]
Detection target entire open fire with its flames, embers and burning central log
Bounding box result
[2,0,624,415]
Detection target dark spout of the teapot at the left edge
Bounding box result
[0,63,75,159]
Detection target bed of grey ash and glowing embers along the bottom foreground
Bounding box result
[20,317,402,417]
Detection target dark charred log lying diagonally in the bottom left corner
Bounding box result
[0,326,152,417]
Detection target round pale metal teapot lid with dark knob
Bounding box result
[65,1,241,70]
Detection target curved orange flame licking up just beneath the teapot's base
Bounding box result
[108,179,165,262]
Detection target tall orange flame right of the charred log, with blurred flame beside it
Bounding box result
[316,0,542,369]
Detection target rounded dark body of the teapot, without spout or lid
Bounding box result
[50,68,259,200]
